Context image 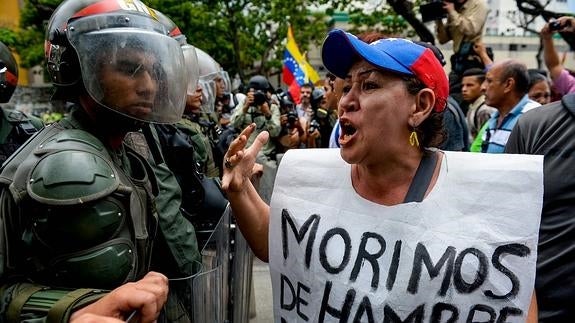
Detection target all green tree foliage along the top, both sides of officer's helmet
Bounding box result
[0,0,416,79]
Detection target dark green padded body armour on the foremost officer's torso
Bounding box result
[0,105,154,321]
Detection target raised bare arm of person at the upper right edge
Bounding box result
[540,16,575,95]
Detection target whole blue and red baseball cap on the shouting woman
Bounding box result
[321,29,449,112]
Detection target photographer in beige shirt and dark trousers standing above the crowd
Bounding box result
[435,0,489,102]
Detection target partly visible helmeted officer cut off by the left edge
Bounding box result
[0,42,44,165]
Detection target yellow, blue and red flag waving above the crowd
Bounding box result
[282,26,319,103]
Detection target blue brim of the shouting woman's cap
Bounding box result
[321,29,413,78]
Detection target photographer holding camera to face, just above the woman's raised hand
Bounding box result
[230,75,281,162]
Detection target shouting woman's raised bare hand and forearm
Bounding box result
[222,123,270,262]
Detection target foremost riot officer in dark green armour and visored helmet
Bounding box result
[0,0,199,322]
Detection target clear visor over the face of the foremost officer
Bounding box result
[67,14,186,123]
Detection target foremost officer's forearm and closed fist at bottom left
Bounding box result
[0,272,168,323]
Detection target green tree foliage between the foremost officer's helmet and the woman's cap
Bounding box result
[149,0,328,78]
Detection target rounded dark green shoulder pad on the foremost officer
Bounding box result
[26,129,120,205]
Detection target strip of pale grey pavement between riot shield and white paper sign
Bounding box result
[249,257,274,323]
